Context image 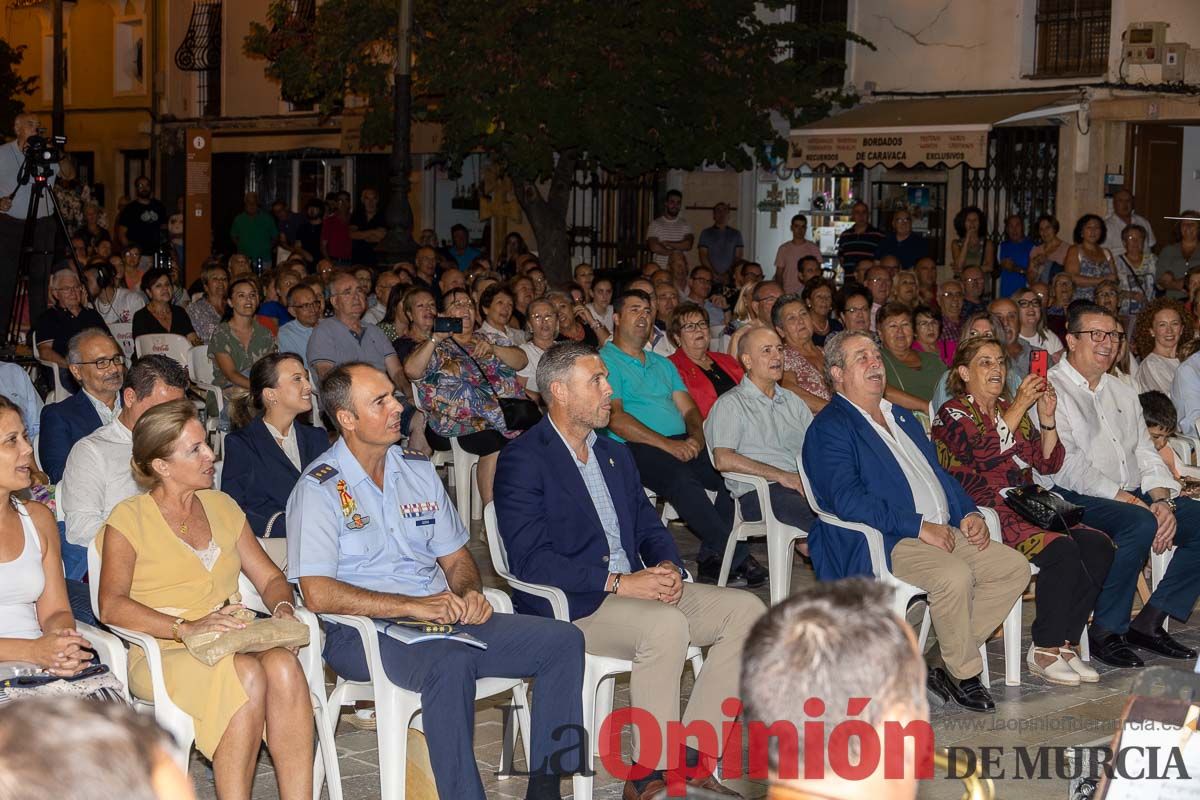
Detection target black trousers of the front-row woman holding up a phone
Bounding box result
[1030,528,1116,648]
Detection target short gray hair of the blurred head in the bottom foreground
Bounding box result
[742,578,932,770]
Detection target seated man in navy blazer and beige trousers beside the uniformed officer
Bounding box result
[496,342,766,799]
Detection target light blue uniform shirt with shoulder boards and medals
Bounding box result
[287,439,468,597]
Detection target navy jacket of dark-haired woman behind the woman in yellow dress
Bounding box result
[221,416,329,539]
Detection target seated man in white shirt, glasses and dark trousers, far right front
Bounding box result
[1038,303,1200,667]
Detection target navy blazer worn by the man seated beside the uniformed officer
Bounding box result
[494,415,683,620]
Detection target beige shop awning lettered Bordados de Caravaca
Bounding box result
[787,92,1079,168]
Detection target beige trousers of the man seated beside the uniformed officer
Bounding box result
[575,583,767,769]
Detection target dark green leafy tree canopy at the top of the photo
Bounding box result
[246,0,865,180]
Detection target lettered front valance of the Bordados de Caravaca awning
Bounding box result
[787,131,988,168]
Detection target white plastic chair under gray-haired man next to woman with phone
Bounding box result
[796,458,1021,686]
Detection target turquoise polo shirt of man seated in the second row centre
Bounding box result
[600,342,688,441]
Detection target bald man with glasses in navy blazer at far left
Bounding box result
[37,327,125,483]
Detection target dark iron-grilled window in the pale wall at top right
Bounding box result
[1033,0,1112,78]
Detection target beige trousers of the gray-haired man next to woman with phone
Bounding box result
[892,531,1030,679]
